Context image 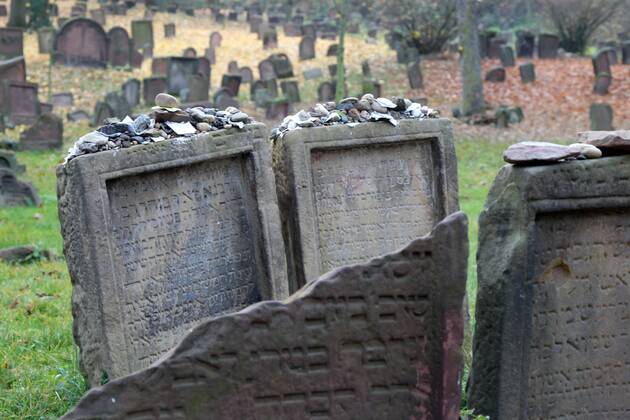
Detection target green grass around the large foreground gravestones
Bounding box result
[0,131,505,419]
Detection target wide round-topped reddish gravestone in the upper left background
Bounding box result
[54,18,107,67]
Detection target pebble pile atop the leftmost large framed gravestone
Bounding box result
[66,93,254,162]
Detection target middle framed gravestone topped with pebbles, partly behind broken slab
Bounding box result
[274,119,458,290]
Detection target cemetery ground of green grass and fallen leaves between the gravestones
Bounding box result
[0,3,630,419]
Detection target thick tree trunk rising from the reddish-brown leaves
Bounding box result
[457,0,485,115]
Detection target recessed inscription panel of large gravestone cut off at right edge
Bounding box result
[526,210,630,419]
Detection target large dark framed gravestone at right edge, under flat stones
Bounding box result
[469,156,630,419]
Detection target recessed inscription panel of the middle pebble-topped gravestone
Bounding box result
[311,140,441,272]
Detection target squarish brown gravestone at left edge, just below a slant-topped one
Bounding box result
[2,80,40,125]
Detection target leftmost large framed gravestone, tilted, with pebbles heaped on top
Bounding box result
[58,124,288,385]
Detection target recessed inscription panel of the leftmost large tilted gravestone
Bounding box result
[107,157,261,369]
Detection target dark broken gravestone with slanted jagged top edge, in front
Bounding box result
[65,213,468,420]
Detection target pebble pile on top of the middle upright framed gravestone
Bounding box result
[271,93,438,140]
